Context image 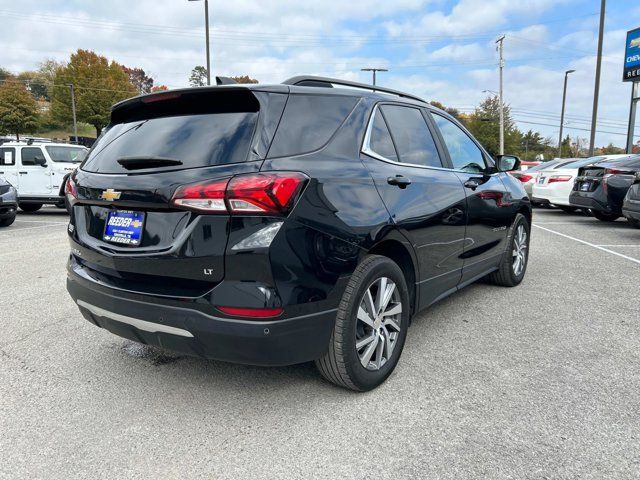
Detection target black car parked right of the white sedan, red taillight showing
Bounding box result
[569,155,640,222]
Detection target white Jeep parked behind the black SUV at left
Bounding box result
[0,141,89,212]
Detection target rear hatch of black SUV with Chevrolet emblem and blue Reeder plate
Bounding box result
[71,87,286,296]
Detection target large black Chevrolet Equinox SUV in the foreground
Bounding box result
[66,77,531,390]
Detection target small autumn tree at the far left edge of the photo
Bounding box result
[0,81,38,139]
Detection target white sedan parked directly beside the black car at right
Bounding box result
[532,155,626,212]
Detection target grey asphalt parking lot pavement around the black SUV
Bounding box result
[0,208,640,478]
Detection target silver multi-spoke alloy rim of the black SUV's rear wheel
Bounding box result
[356,277,402,371]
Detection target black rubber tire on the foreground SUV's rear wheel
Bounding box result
[315,255,410,392]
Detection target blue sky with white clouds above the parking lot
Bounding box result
[0,0,640,146]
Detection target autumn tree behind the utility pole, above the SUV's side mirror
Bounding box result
[465,97,522,155]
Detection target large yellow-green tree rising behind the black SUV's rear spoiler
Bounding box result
[51,49,138,135]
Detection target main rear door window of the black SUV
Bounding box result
[380,105,442,167]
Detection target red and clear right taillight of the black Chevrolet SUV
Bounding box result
[171,172,308,215]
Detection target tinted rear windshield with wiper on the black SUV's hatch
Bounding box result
[82,112,258,173]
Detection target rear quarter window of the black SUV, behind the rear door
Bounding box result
[269,94,358,157]
